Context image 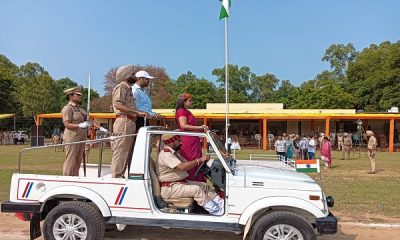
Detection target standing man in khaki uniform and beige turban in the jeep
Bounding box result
[111,65,148,178]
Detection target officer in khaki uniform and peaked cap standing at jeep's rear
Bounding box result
[61,87,108,176]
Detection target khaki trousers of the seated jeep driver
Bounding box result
[161,181,217,206]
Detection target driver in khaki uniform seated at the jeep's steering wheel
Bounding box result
[157,134,224,215]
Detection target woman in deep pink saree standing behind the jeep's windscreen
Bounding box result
[175,93,207,182]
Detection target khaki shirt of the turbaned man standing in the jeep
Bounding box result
[112,82,135,115]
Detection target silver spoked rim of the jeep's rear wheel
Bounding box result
[53,214,87,240]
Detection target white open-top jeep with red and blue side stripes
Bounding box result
[1,127,337,240]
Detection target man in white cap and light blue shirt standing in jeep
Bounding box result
[132,70,161,131]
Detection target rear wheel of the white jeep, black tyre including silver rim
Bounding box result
[43,201,105,240]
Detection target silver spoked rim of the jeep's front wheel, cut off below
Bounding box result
[263,224,304,240]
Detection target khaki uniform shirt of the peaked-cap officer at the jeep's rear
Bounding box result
[61,102,87,142]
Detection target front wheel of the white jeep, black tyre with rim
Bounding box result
[251,212,317,240]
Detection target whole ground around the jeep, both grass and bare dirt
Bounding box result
[0,145,400,240]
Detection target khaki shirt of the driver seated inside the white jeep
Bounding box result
[156,146,189,182]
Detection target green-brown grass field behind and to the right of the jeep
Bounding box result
[0,143,400,221]
